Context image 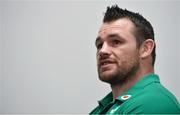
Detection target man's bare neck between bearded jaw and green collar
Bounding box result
[111,69,154,99]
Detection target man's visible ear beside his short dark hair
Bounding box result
[140,39,155,58]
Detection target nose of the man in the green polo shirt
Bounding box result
[98,43,110,59]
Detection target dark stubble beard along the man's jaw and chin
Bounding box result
[98,57,140,85]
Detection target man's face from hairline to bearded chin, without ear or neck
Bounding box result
[95,18,139,84]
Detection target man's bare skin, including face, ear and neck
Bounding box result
[95,18,154,98]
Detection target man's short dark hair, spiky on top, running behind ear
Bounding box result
[103,5,156,66]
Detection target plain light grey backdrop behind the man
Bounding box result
[0,0,180,113]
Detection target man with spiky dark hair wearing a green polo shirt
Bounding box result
[90,5,180,114]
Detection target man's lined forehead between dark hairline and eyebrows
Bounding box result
[98,18,135,37]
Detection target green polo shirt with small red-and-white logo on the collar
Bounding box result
[90,73,180,114]
